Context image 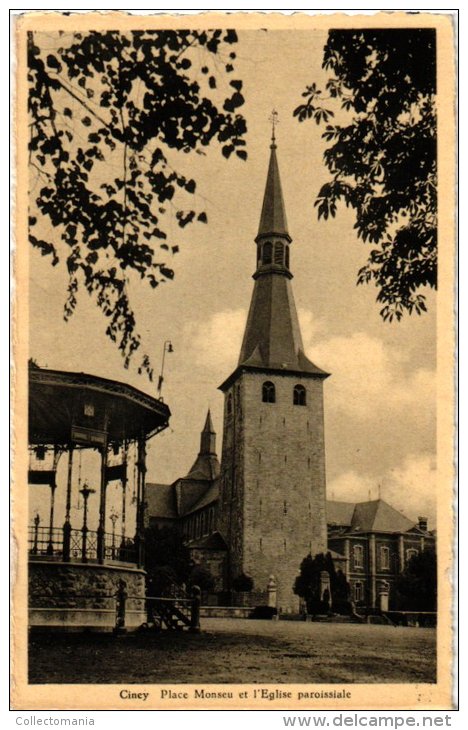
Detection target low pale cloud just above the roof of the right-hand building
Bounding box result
[327,453,437,529]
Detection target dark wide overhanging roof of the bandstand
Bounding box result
[29,362,171,448]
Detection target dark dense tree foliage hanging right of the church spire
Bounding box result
[294,29,437,321]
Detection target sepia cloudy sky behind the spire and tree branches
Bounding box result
[30,31,436,518]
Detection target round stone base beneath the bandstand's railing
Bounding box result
[28,559,146,631]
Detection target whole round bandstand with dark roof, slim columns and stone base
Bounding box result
[28,362,170,630]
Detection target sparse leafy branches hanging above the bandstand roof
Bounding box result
[28,29,247,376]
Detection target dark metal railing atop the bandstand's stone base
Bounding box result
[28,523,137,563]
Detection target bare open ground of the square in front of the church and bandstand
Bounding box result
[29,618,436,684]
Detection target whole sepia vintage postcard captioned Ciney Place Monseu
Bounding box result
[12,12,456,710]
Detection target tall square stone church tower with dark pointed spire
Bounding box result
[219,128,328,611]
